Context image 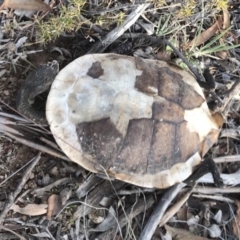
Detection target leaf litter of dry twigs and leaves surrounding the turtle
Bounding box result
[0,0,240,239]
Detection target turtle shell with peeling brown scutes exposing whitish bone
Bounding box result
[46,54,222,188]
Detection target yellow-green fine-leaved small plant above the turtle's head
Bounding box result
[38,0,86,43]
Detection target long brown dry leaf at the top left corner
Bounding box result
[0,0,51,11]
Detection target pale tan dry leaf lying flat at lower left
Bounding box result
[10,203,47,216]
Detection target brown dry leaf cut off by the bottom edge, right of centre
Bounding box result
[164,225,209,240]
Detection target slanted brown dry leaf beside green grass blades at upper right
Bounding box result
[188,18,223,48]
